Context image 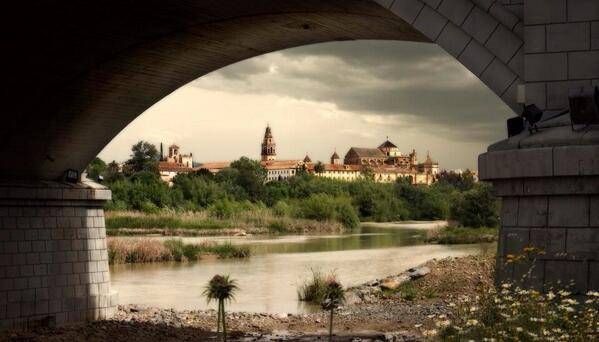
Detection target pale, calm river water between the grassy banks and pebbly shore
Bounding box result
[110,223,495,313]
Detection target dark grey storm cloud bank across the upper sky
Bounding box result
[195,41,511,142]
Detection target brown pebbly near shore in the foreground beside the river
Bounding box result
[0,256,493,341]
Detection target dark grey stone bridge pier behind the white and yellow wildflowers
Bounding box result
[479,124,599,293]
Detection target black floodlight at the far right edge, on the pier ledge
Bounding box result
[568,87,599,127]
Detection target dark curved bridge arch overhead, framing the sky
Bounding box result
[0,0,523,180]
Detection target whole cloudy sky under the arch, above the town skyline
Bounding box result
[100,41,512,169]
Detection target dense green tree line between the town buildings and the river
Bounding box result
[87,141,498,227]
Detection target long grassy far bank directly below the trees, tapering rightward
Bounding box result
[105,210,346,236]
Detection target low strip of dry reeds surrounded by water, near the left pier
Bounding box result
[108,238,251,264]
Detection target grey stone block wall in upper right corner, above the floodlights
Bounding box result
[524,0,599,110]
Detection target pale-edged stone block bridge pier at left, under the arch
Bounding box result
[0,182,117,329]
